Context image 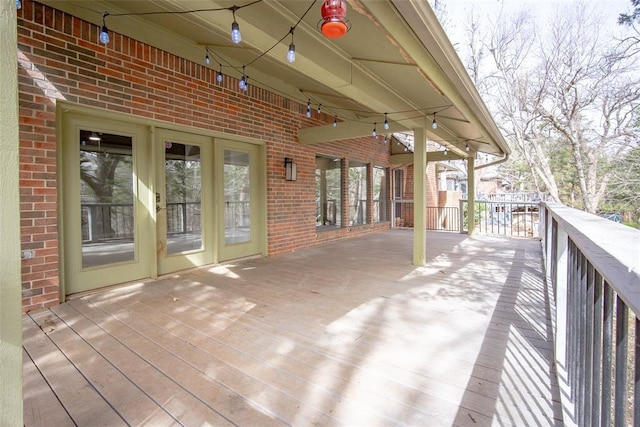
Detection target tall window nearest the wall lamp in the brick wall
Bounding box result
[316,156,342,230]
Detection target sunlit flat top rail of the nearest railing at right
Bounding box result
[544,202,640,316]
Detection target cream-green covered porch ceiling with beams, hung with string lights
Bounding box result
[42,0,509,157]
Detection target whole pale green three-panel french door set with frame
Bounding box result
[59,114,266,295]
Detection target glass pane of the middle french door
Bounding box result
[164,141,203,255]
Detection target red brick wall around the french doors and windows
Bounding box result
[18,0,389,311]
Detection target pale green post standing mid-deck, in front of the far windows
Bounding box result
[413,123,427,266]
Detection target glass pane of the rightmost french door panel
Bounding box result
[224,150,251,245]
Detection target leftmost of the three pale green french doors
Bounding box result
[59,115,154,294]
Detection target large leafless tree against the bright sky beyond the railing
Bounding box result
[456,3,640,212]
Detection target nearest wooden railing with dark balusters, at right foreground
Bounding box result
[541,203,640,426]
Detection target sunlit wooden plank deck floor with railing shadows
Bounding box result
[24,230,562,426]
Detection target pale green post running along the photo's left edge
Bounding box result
[0,1,23,426]
